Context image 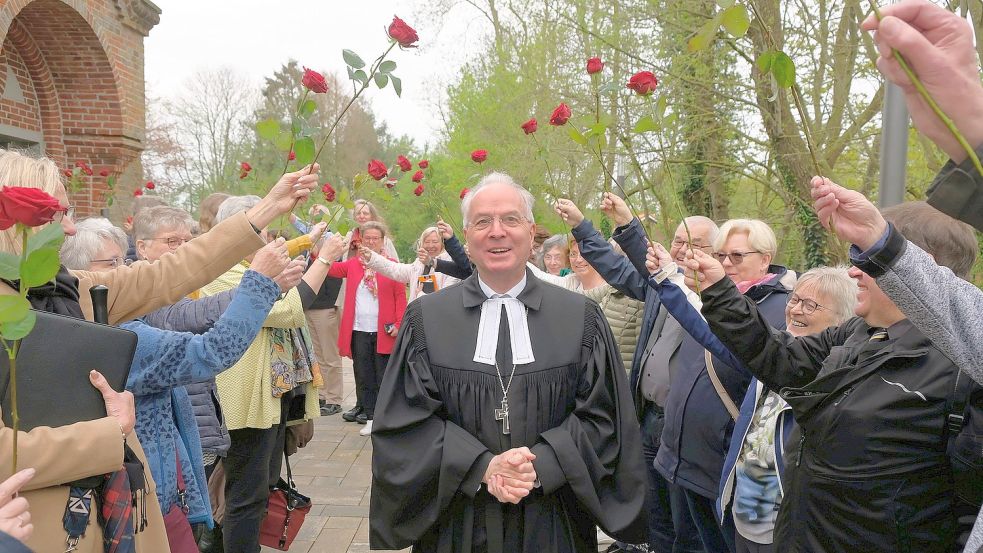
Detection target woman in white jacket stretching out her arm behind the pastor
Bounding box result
[361,221,460,301]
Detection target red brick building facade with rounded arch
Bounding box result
[0,0,160,216]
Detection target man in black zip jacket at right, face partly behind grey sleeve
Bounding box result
[688,204,983,553]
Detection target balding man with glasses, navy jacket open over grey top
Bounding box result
[557,196,717,553]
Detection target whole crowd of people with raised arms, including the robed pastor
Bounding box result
[0,0,983,553]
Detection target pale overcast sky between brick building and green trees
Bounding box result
[145,0,486,146]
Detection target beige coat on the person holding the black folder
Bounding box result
[0,214,263,553]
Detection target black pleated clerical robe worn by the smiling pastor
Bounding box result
[369,273,648,553]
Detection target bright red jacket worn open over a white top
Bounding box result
[328,256,406,358]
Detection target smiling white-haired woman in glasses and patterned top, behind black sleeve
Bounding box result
[717,267,857,553]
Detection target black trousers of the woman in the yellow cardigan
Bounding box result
[222,392,293,553]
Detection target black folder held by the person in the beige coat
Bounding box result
[0,311,137,431]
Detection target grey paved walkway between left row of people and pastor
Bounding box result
[263,359,610,553]
